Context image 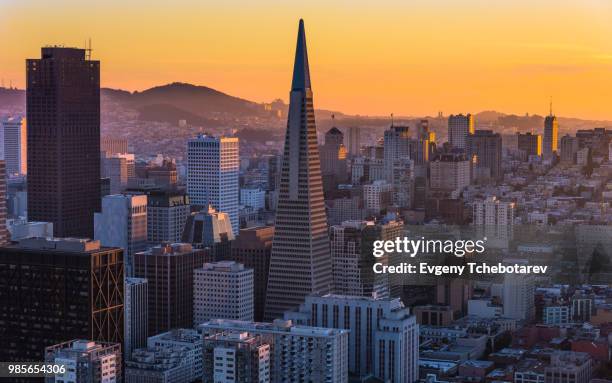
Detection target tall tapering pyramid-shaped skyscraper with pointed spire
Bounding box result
[265,20,332,320]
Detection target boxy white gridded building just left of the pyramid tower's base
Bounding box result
[193,261,255,325]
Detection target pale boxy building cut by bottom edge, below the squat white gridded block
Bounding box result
[203,331,271,383]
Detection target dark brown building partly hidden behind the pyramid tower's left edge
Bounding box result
[228,226,274,322]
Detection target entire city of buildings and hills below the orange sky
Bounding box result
[0,3,612,383]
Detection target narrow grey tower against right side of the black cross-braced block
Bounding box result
[123,278,149,360]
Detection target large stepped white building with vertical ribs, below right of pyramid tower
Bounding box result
[285,294,419,383]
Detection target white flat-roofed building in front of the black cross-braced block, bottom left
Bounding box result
[45,340,121,383]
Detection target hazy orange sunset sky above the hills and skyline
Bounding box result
[0,0,612,120]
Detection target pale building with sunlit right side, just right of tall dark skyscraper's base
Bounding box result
[94,194,147,277]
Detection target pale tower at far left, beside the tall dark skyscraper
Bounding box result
[0,117,28,177]
